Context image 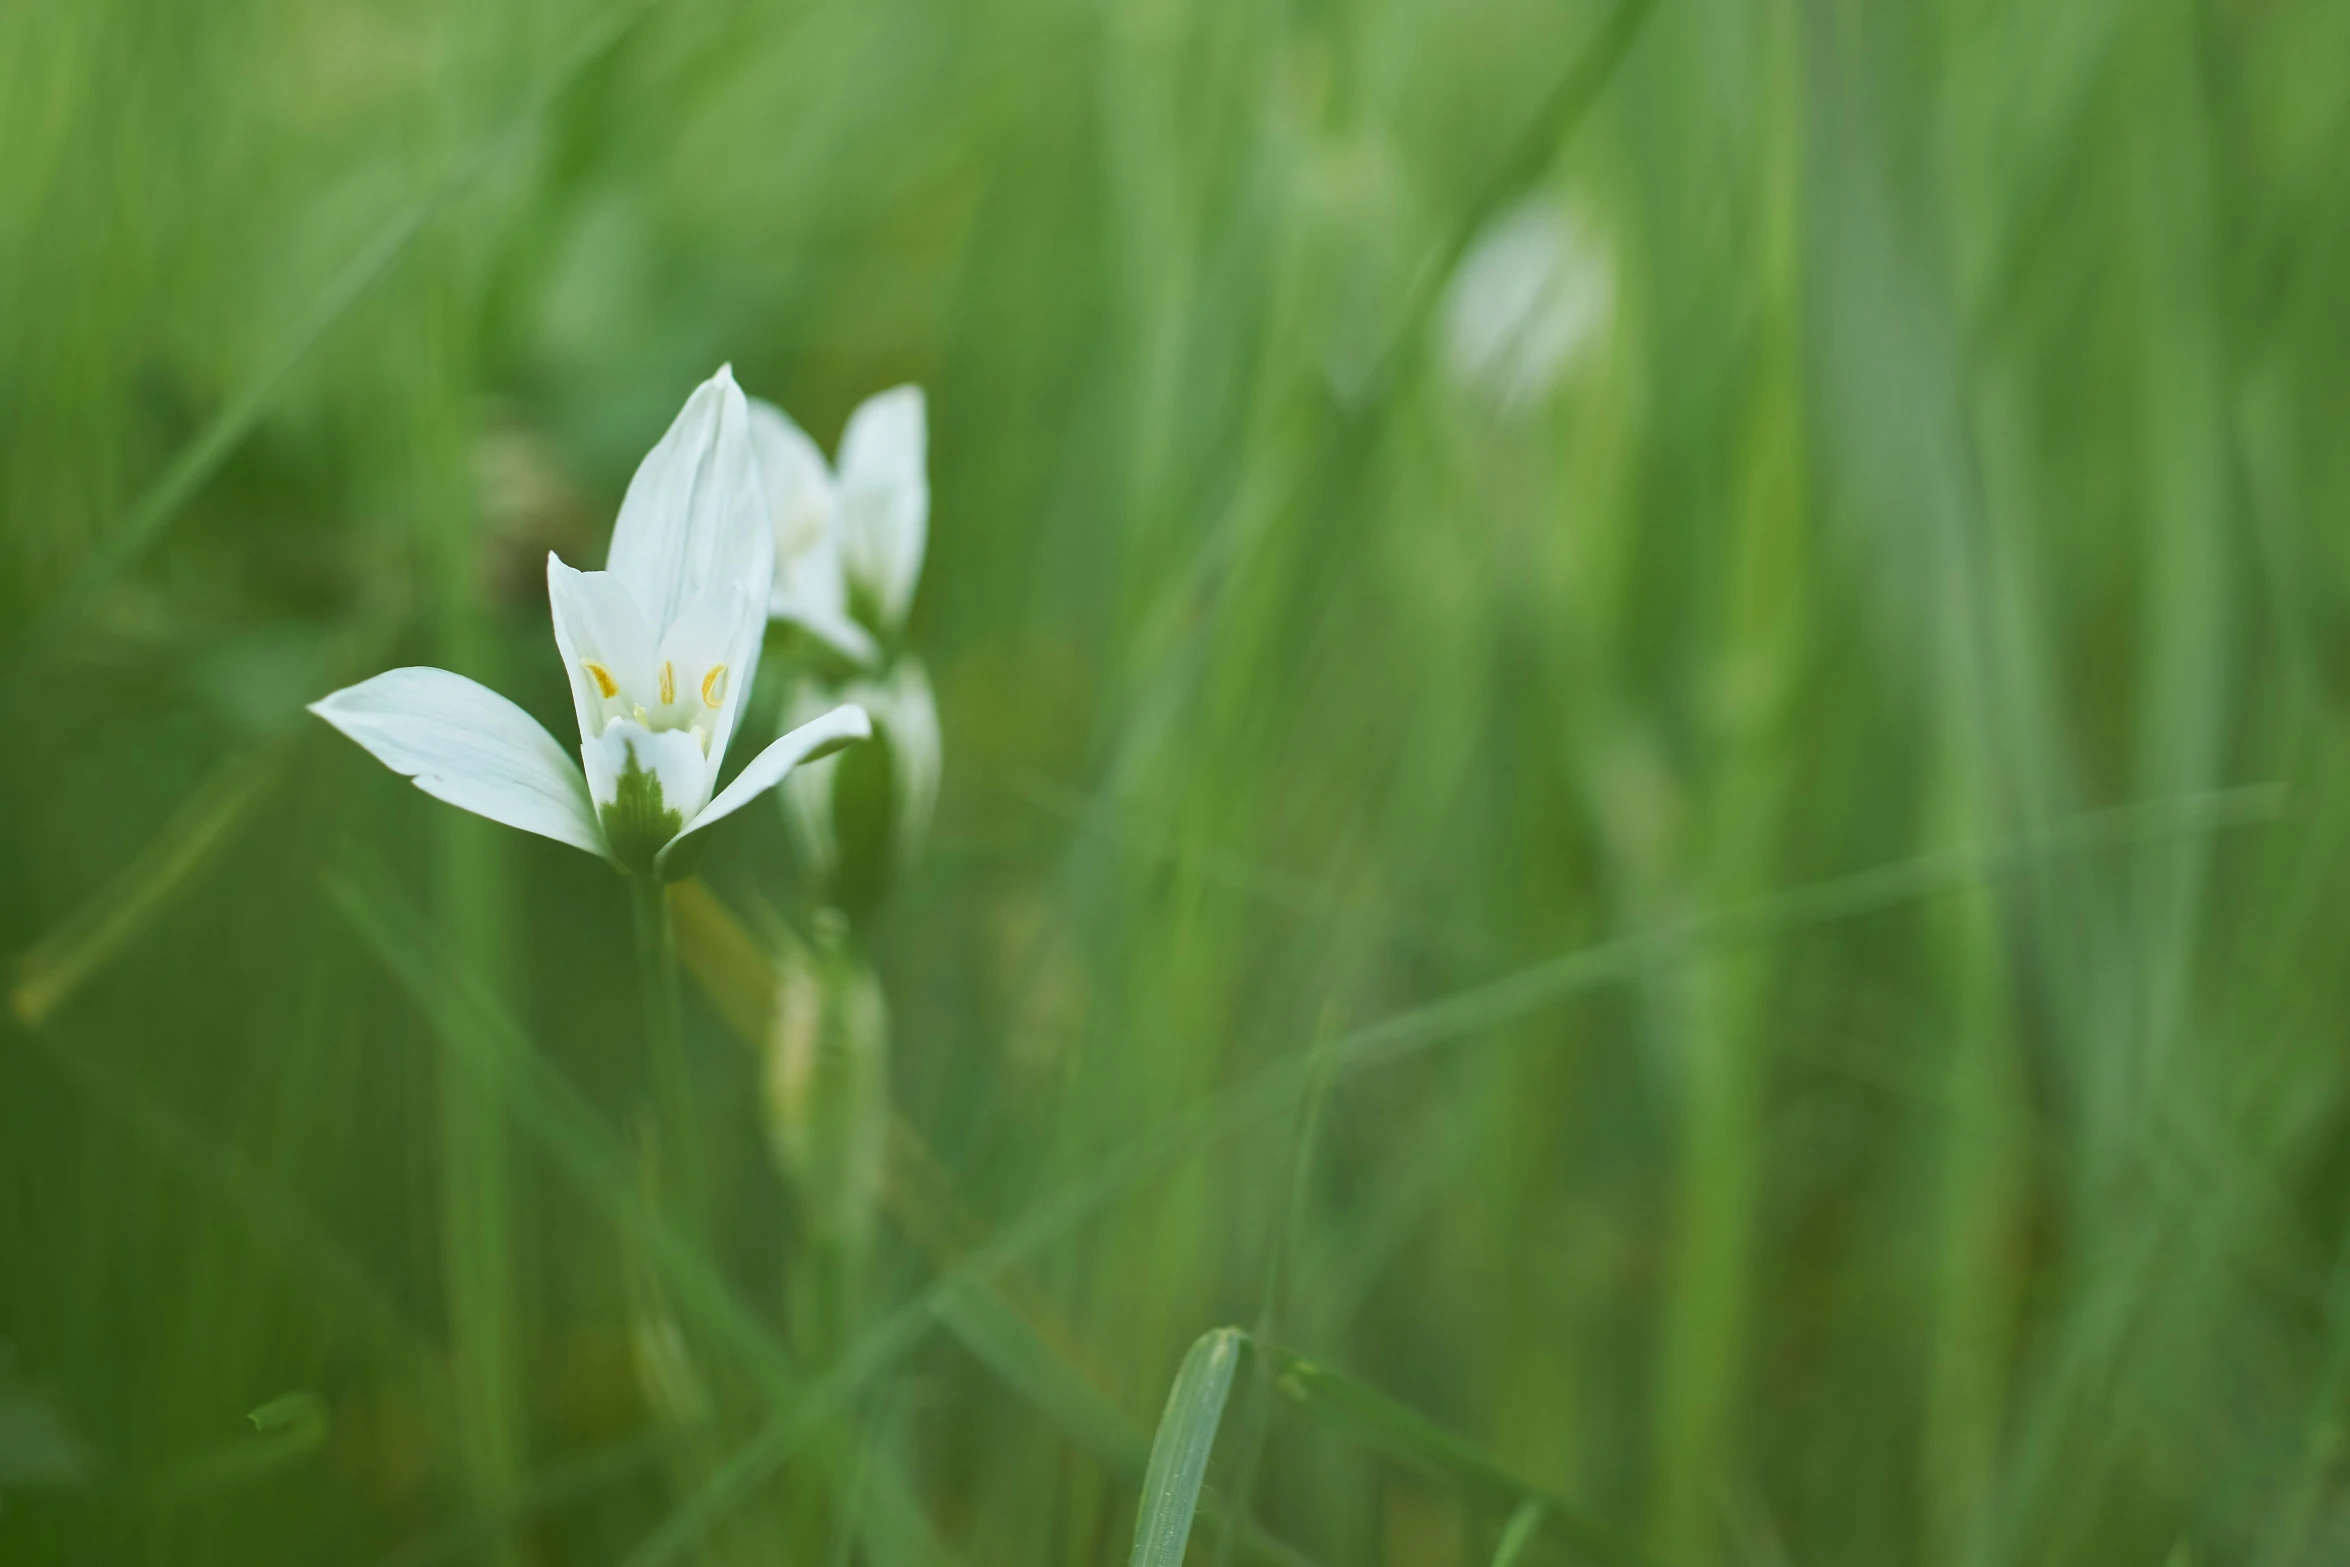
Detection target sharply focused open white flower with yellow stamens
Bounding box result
[310,369,872,874]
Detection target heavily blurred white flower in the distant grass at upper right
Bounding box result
[1443,195,1614,411]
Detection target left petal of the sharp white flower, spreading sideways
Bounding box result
[310,670,604,855]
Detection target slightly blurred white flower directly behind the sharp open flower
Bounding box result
[750,385,931,648]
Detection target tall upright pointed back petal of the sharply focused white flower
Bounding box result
[609,369,776,639]
